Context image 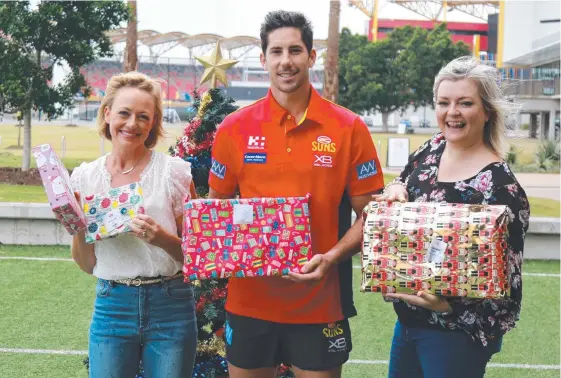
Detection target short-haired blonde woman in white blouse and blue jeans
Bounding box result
[71,72,197,378]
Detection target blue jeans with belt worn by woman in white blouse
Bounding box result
[89,279,197,378]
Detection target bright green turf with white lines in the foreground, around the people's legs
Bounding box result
[0,246,560,378]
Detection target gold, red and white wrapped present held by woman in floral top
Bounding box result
[361,202,510,298]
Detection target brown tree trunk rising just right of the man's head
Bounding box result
[323,0,341,103]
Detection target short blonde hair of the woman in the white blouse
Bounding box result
[96,71,164,148]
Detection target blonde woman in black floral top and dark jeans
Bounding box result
[376,57,530,378]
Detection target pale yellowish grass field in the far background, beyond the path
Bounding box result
[0,124,538,169]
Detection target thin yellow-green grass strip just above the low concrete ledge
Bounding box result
[0,182,561,218]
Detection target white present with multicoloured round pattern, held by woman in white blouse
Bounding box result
[83,183,144,244]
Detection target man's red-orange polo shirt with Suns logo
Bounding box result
[209,88,384,324]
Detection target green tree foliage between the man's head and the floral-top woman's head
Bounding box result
[339,24,469,130]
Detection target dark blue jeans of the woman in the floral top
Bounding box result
[388,320,502,378]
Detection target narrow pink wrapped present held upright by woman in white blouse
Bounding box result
[32,144,86,235]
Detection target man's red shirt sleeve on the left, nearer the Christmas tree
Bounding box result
[208,123,238,195]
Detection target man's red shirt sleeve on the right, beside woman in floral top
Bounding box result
[348,117,384,196]
